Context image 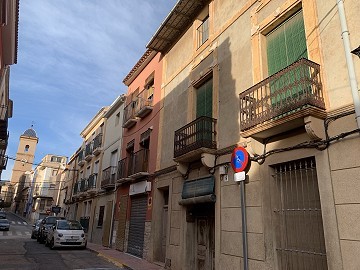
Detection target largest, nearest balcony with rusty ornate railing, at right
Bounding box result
[239,58,326,140]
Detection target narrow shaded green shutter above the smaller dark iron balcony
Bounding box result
[196,79,212,118]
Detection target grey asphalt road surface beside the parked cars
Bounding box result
[0,213,123,270]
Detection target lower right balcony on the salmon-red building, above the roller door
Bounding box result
[127,149,149,179]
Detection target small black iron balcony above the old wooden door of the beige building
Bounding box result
[174,116,217,162]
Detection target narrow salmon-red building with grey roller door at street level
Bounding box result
[116,50,162,260]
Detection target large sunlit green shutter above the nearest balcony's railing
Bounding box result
[266,11,307,76]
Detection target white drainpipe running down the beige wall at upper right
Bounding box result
[336,0,360,129]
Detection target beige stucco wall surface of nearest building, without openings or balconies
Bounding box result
[154,0,360,269]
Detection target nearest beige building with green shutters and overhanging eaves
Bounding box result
[145,0,360,270]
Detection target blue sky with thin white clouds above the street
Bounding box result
[1,0,176,180]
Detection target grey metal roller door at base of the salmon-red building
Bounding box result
[127,196,147,258]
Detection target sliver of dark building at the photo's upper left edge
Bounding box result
[0,0,19,175]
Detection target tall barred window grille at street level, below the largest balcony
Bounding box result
[271,157,327,270]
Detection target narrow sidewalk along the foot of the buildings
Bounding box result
[87,242,164,270]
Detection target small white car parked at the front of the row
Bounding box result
[45,220,87,249]
